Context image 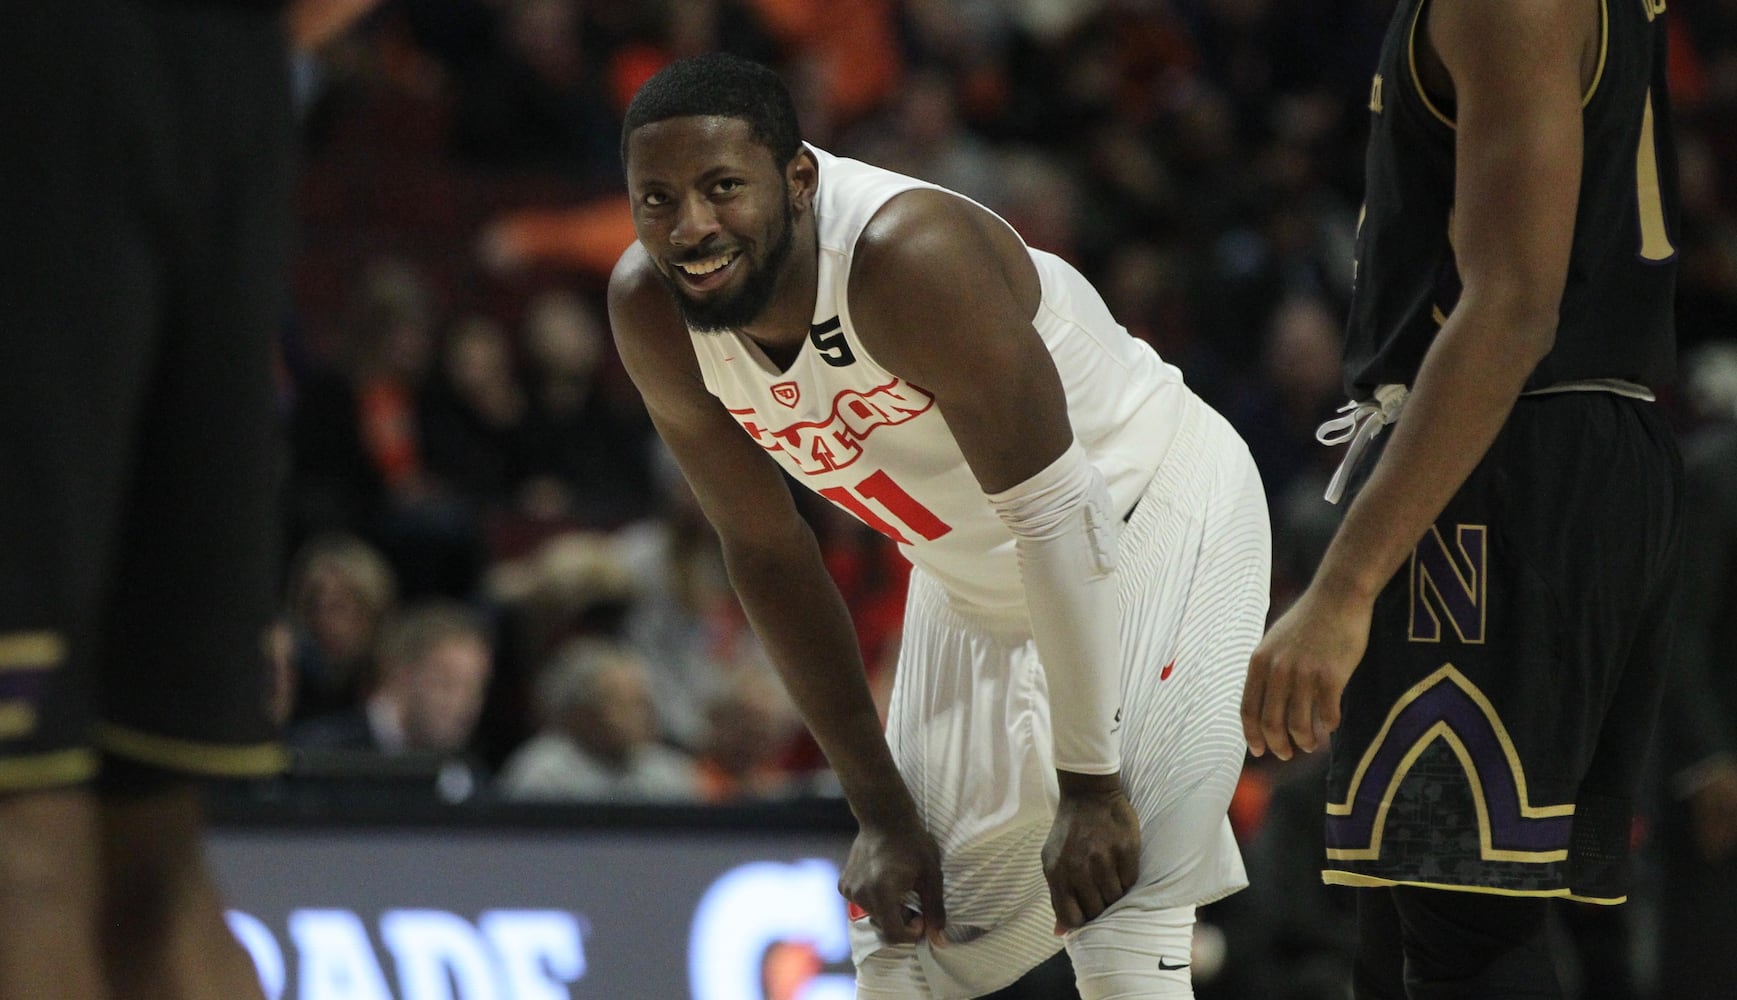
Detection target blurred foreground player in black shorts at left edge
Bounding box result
[0,0,365,1000]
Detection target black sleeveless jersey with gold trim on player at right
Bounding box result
[1344,0,1678,399]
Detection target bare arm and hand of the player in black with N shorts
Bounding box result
[1242,0,1600,759]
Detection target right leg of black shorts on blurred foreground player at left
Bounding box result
[99,7,292,774]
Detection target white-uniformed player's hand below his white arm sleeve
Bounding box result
[1044,773,1139,934]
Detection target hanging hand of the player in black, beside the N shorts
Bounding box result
[1242,585,1372,760]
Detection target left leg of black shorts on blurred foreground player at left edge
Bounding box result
[0,0,163,792]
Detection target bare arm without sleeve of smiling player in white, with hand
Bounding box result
[610,245,947,941]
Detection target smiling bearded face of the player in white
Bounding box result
[627,116,796,330]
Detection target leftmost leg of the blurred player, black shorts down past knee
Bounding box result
[0,0,178,1000]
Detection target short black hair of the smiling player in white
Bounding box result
[622,52,802,167]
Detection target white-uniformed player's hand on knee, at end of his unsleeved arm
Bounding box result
[839,823,947,946]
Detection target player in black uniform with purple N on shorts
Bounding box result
[1244,0,1681,1000]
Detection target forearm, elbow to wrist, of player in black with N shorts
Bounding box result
[1315,302,1549,601]
